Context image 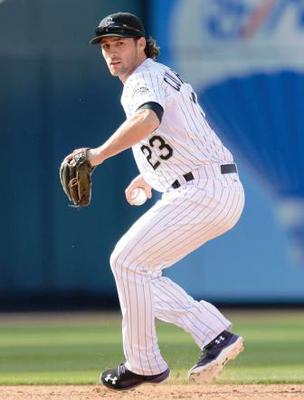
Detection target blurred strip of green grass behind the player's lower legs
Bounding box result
[0,312,304,385]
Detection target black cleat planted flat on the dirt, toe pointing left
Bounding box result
[99,364,170,390]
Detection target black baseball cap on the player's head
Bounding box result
[90,12,145,44]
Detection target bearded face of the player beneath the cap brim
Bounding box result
[101,36,146,82]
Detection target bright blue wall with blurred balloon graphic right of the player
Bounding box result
[150,0,304,303]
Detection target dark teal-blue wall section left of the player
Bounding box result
[0,0,150,302]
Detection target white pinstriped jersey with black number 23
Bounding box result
[121,58,233,192]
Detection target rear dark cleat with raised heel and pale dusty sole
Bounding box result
[188,331,244,383]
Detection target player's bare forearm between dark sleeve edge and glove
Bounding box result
[89,109,160,166]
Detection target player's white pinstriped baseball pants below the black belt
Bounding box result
[110,174,244,375]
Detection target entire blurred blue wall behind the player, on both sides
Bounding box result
[0,0,304,311]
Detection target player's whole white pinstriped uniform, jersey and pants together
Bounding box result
[110,59,244,375]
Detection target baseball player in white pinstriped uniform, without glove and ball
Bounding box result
[66,12,244,390]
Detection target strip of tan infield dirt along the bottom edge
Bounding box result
[0,384,304,400]
